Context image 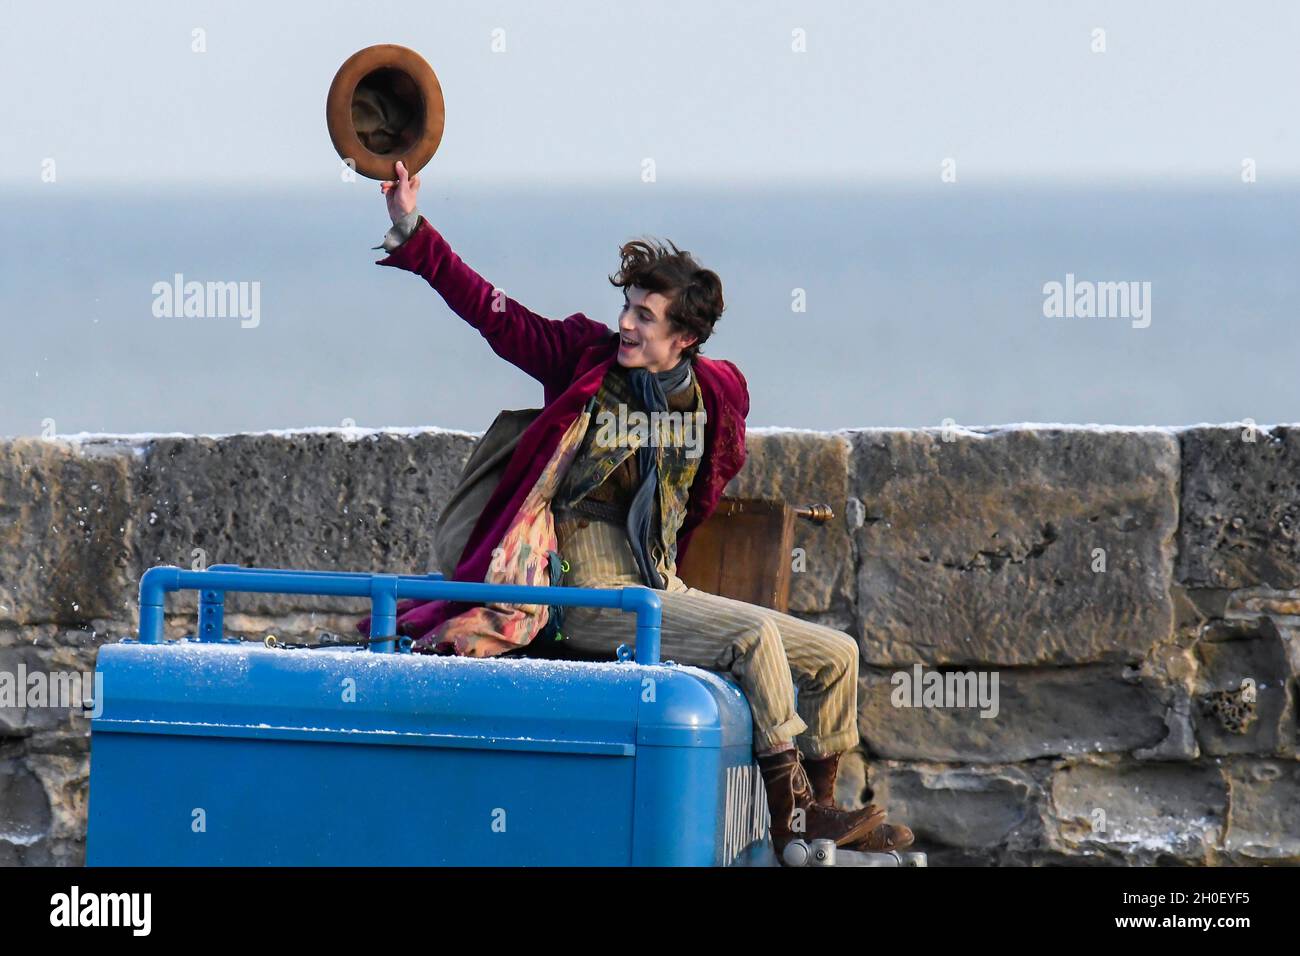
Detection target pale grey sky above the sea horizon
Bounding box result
[0,0,1300,190]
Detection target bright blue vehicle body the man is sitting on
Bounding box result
[87,571,770,866]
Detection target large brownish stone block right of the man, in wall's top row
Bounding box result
[853,428,1178,665]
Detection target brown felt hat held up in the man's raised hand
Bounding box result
[325,43,445,179]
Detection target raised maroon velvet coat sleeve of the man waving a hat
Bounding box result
[377,216,616,394]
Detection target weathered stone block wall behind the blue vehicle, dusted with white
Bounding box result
[0,425,1300,865]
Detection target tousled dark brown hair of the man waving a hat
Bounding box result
[610,239,725,359]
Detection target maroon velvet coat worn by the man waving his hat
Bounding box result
[358,217,749,637]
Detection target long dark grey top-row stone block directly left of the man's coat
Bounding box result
[133,431,476,614]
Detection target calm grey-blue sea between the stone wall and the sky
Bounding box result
[0,183,1300,436]
